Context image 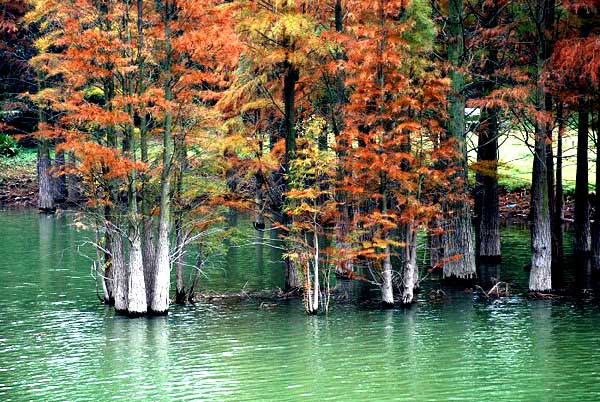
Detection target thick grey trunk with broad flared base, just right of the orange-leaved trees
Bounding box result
[442,0,476,278]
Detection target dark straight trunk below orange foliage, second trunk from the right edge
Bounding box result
[573,100,591,255]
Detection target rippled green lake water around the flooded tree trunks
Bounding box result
[0,211,600,401]
